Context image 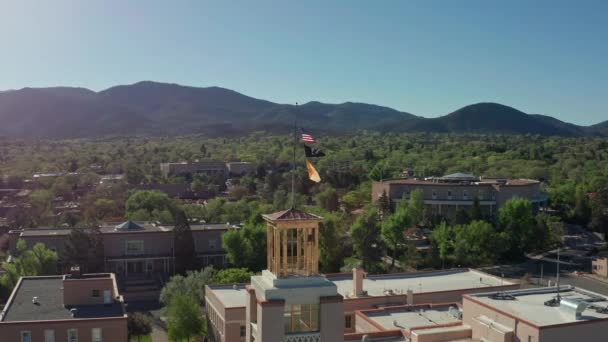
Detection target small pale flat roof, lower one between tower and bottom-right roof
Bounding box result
[361,304,462,330]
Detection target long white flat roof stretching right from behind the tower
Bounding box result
[327,269,514,298]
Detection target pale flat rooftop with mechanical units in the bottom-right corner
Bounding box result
[465,286,608,327]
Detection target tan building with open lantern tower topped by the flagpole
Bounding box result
[205,209,519,342]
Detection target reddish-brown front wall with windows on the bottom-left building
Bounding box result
[0,317,128,342]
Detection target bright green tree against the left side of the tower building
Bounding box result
[167,293,203,341]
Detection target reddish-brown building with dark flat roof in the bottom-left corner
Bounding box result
[0,267,128,342]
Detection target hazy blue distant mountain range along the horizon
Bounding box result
[0,81,608,138]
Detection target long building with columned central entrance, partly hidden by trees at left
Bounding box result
[9,221,232,279]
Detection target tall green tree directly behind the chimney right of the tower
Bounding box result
[351,207,383,273]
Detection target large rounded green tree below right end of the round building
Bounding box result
[498,198,536,257]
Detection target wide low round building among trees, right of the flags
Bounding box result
[372,173,547,218]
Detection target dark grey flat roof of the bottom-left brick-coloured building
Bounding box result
[0,276,123,322]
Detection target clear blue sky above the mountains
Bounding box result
[0,0,608,124]
